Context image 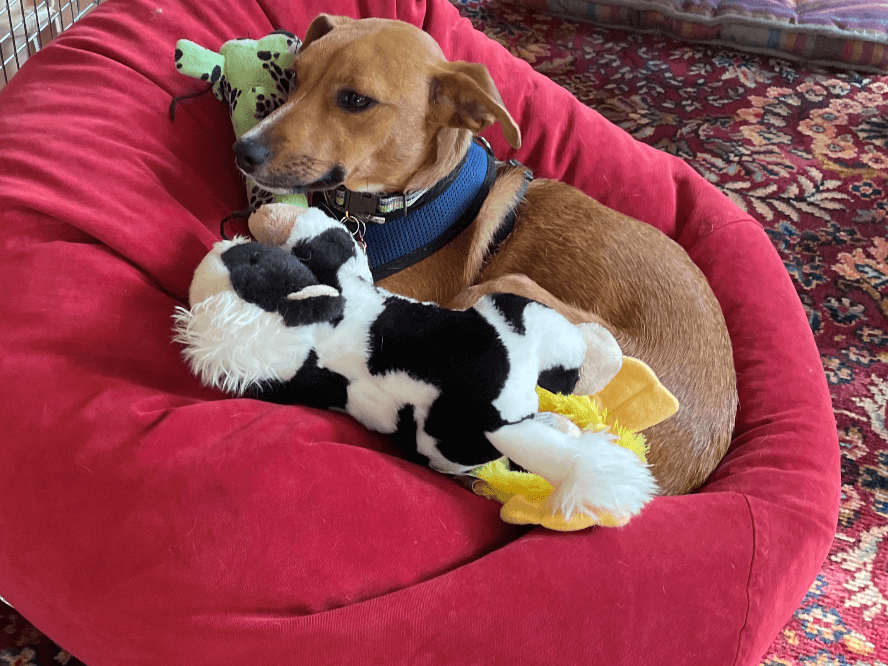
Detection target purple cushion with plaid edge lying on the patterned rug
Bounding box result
[516,0,888,72]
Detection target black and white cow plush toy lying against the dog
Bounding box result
[176,204,656,520]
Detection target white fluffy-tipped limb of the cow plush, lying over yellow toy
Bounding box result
[487,419,657,520]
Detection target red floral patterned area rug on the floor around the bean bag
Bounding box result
[0,0,888,666]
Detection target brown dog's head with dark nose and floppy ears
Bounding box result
[234,14,521,194]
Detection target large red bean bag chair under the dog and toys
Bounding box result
[0,0,839,666]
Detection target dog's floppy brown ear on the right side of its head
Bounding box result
[429,61,521,148]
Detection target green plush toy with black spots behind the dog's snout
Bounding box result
[176,30,308,211]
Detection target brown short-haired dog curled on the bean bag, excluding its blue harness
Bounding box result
[235,15,737,494]
